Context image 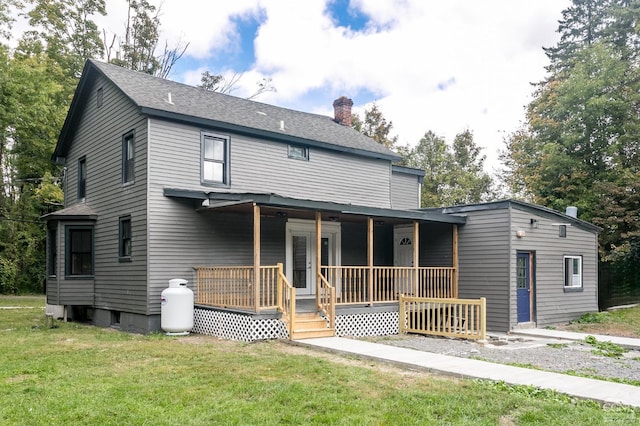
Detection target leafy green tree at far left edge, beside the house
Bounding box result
[0,48,67,293]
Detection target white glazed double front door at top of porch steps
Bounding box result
[286,219,340,296]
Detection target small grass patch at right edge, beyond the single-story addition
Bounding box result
[564,306,640,338]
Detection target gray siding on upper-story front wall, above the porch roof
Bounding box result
[150,119,391,207]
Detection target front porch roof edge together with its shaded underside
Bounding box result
[164,188,466,224]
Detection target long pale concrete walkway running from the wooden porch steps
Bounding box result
[296,330,640,407]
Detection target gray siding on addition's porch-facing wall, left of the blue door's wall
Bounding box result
[458,209,510,331]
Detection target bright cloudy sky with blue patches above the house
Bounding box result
[18,0,570,171]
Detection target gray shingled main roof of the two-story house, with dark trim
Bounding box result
[53,59,400,161]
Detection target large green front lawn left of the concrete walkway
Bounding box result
[0,297,640,425]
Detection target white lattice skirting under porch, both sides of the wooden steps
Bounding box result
[192,307,400,342]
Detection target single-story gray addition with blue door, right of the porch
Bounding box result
[432,200,600,331]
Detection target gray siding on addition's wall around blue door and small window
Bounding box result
[510,208,598,327]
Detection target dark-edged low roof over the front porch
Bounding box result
[164,188,466,224]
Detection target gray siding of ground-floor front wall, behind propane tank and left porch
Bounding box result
[148,195,285,314]
